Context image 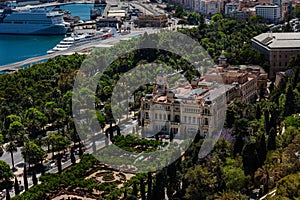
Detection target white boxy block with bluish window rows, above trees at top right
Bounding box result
[255,5,281,23]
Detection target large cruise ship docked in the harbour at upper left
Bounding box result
[0,9,69,35]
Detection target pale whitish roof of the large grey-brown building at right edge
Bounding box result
[252,32,300,49]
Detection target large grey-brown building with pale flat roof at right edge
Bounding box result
[252,32,300,78]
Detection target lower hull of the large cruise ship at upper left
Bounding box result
[0,23,67,35]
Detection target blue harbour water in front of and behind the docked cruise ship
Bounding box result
[0,4,99,66]
